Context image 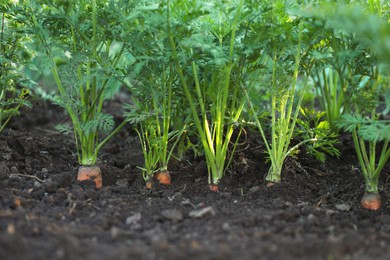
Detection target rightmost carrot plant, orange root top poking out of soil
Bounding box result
[338,70,390,209]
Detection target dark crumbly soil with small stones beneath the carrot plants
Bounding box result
[0,98,390,260]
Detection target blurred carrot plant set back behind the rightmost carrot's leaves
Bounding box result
[311,24,371,131]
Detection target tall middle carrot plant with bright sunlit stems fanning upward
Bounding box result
[167,1,245,190]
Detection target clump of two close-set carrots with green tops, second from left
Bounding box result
[125,2,186,185]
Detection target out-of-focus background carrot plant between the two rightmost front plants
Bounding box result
[300,5,365,132]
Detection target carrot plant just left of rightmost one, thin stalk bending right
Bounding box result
[244,1,318,183]
